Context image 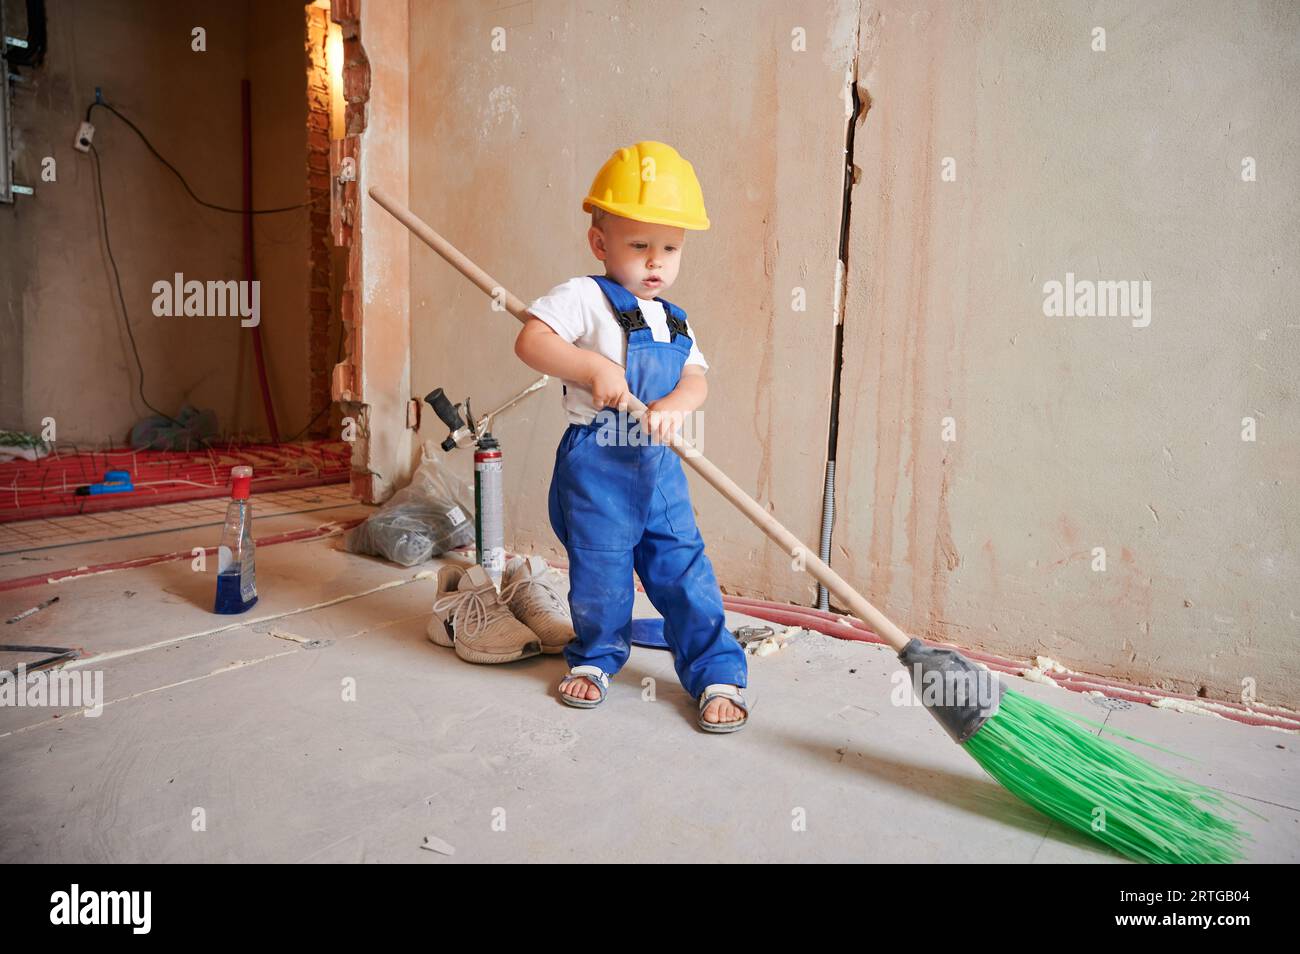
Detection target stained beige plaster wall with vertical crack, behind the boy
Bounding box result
[410,0,1300,704]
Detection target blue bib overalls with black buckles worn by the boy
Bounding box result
[549,276,746,698]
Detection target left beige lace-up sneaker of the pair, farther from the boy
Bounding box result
[426,563,542,663]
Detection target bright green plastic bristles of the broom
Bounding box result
[963,690,1253,864]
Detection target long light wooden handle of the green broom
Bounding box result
[369,186,910,650]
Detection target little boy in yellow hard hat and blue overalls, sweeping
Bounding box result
[515,142,749,732]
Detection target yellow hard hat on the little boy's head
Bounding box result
[582,140,709,230]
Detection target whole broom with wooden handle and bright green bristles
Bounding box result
[369,187,1245,863]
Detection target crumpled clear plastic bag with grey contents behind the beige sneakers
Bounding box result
[345,442,475,567]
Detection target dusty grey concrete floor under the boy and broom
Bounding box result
[0,491,1300,863]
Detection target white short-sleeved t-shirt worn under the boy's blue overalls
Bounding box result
[528,276,709,424]
